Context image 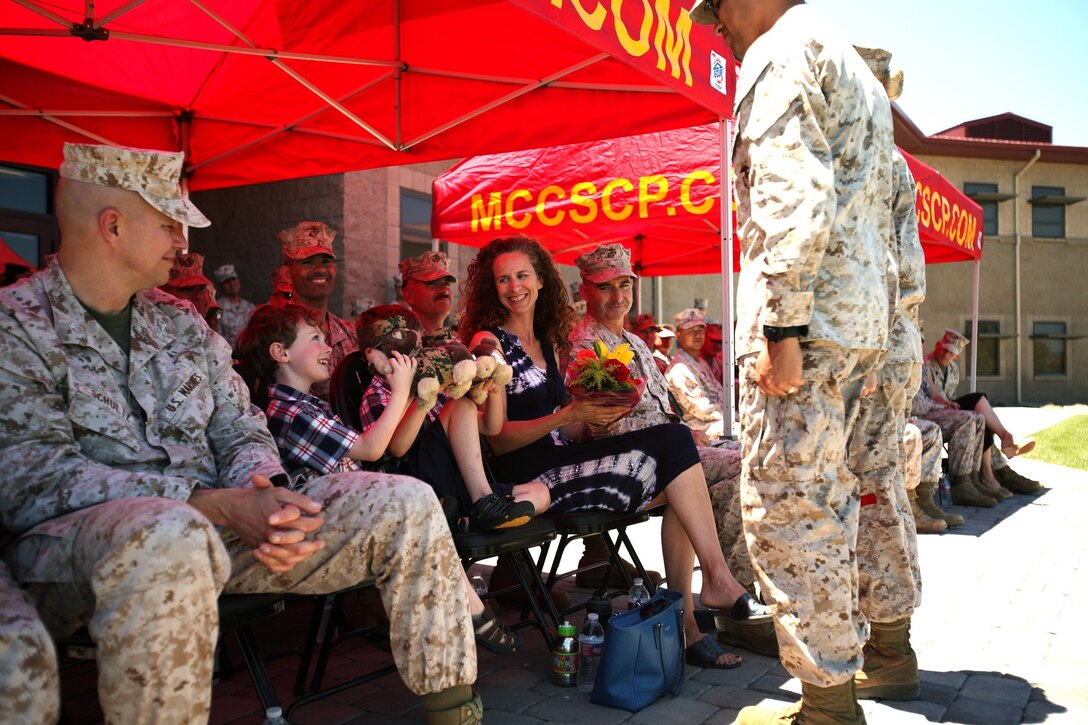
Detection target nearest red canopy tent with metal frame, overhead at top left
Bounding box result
[0,0,732,189]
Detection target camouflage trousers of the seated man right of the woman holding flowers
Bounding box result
[698,441,755,587]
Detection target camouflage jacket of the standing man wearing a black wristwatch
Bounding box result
[732,4,898,356]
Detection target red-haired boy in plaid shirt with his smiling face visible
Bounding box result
[238,303,521,654]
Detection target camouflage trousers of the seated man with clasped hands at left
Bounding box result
[7,472,477,723]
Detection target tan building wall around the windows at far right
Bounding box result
[919,150,1088,405]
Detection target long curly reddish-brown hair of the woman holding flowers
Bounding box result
[458,236,576,359]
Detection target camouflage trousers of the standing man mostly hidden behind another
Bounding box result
[846,363,922,622]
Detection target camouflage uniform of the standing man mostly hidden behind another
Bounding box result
[849,149,926,623]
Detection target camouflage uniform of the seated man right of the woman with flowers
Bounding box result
[569,315,755,586]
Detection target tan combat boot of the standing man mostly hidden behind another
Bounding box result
[854,617,922,700]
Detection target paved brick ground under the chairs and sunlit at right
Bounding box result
[61,406,1088,725]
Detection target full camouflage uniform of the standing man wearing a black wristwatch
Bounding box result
[732,5,898,687]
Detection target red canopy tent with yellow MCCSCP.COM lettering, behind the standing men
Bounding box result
[431,124,982,267]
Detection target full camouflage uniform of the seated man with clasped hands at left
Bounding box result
[0,261,475,722]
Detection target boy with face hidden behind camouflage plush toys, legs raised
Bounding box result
[356,305,552,529]
